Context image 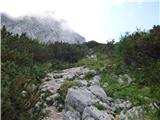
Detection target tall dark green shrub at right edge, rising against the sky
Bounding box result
[115,25,160,86]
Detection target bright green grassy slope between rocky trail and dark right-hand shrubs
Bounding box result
[79,54,160,120]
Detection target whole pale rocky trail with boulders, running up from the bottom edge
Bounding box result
[41,67,146,120]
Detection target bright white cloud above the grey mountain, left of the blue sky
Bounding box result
[0,0,110,43]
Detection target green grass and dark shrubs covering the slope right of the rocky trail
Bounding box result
[79,26,160,120]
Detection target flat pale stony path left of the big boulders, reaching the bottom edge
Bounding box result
[41,67,89,120]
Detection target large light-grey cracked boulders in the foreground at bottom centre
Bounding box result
[64,85,113,120]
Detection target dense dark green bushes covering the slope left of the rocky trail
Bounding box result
[1,27,85,120]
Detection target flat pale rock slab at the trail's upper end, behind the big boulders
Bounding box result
[42,67,89,94]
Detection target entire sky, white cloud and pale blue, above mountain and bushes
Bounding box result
[0,0,160,43]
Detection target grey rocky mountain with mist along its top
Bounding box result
[1,13,85,43]
